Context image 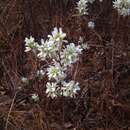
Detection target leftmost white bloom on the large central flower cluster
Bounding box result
[25,36,38,52]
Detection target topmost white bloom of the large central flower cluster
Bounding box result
[48,27,66,43]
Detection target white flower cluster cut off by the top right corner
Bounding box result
[113,0,130,16]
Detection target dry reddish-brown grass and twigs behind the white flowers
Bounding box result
[0,0,130,130]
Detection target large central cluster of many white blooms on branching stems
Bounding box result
[25,27,88,98]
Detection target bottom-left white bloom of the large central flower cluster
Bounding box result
[46,82,58,98]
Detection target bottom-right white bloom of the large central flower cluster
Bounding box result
[62,80,80,97]
